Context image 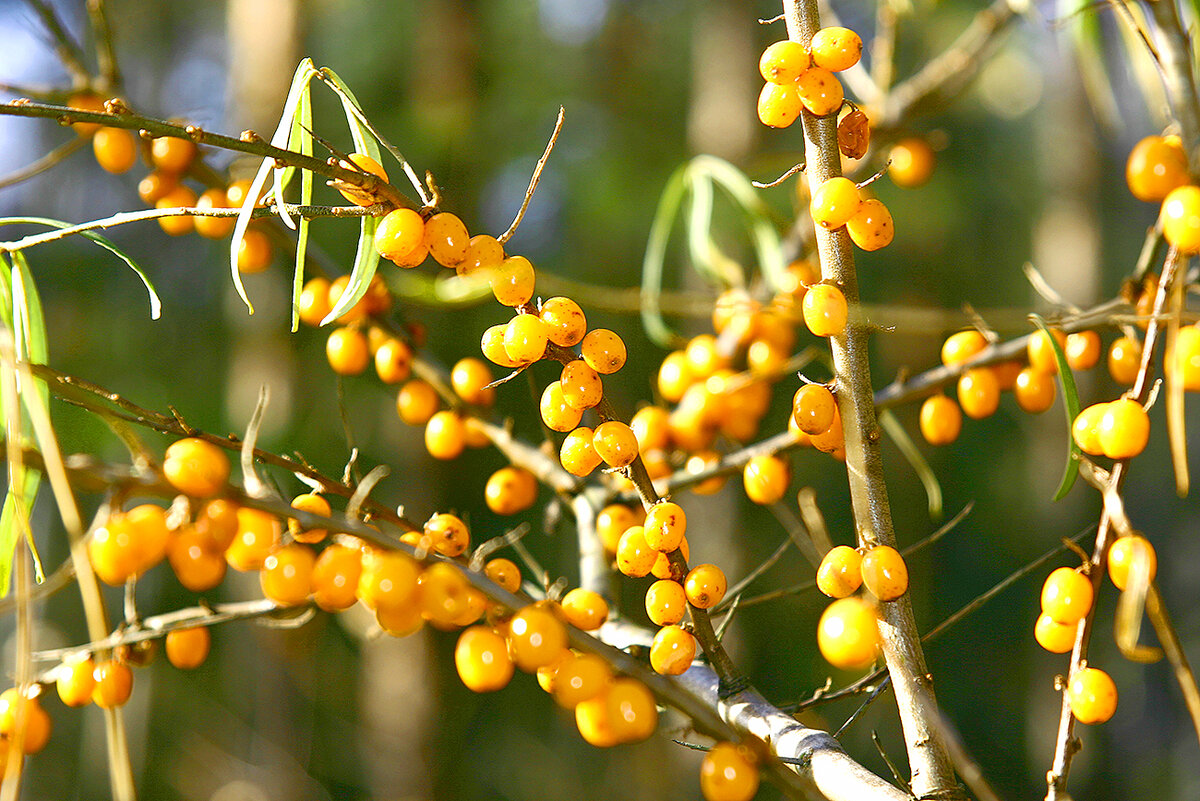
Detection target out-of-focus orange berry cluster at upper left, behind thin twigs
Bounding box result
[67,95,274,273]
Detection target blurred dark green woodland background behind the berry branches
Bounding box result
[0,0,1200,801]
